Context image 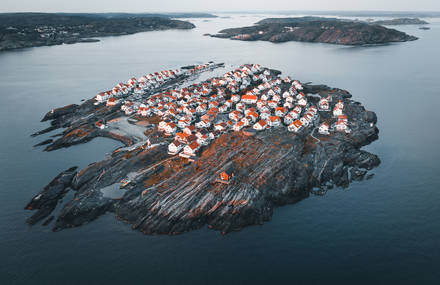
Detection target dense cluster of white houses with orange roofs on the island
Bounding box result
[96,64,348,157]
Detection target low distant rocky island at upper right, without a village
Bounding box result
[210,17,417,45]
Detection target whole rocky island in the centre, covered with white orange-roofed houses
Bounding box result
[25,62,380,234]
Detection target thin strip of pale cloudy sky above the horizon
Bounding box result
[0,0,440,12]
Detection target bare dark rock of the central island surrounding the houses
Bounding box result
[25,64,380,234]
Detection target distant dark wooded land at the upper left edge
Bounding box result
[0,13,204,51]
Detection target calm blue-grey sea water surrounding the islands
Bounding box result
[0,15,440,284]
